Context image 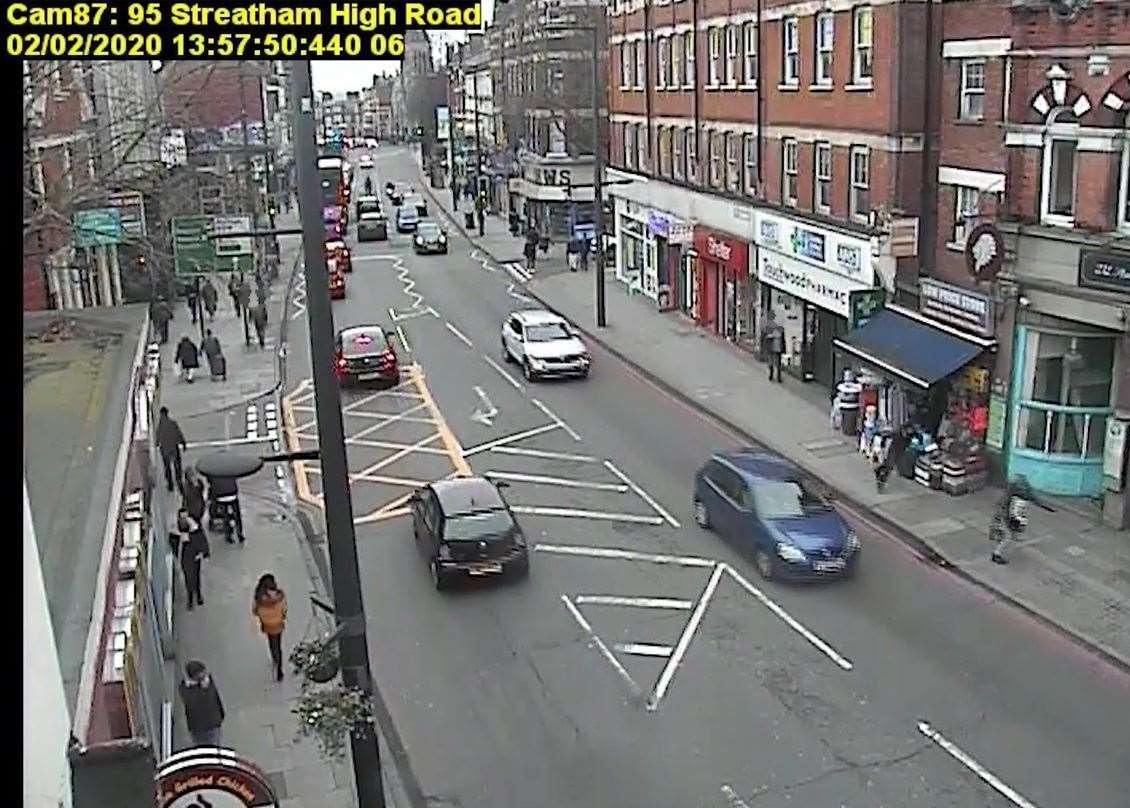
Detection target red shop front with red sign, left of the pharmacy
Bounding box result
[694,227,750,339]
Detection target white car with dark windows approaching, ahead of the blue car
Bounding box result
[502,310,592,382]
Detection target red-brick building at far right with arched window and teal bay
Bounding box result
[932,0,1130,517]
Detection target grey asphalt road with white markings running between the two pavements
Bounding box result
[284,147,1130,808]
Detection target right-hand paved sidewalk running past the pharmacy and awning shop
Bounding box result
[418,169,1130,668]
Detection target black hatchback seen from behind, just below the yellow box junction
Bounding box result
[410,477,530,590]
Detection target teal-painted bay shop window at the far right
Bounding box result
[1008,318,1116,497]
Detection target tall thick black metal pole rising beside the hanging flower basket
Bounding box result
[290,61,384,808]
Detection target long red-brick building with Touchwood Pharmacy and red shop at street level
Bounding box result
[609,0,936,384]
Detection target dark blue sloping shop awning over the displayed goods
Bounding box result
[833,306,997,389]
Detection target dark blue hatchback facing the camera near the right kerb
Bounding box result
[695,450,860,580]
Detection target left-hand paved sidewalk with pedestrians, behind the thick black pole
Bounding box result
[155,216,409,808]
